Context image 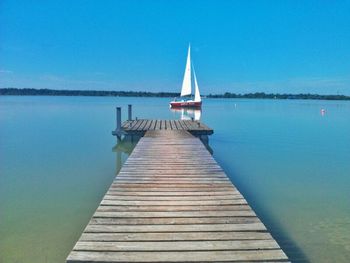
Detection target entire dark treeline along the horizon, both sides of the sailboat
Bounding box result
[0,88,350,100]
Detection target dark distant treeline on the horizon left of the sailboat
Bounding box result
[0,88,180,97]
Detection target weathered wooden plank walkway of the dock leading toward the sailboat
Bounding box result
[67,131,288,263]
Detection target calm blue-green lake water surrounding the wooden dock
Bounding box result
[0,97,350,263]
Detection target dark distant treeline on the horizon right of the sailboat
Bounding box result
[207,92,350,100]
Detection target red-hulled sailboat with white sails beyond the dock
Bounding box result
[170,46,202,108]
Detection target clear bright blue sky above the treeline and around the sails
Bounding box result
[0,0,350,95]
